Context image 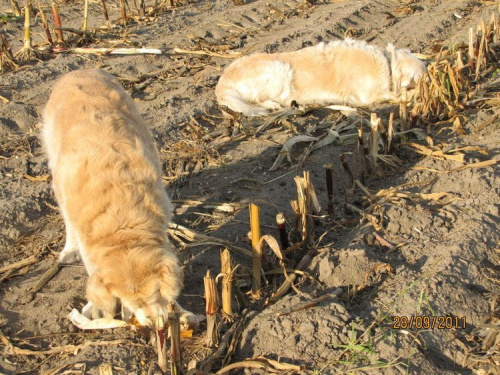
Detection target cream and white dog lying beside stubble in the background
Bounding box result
[215,39,425,116]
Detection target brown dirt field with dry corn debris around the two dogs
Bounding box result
[0,0,500,374]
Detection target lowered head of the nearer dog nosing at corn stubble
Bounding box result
[87,245,183,372]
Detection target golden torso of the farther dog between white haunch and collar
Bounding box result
[283,39,390,106]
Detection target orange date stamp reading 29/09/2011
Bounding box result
[392,315,467,329]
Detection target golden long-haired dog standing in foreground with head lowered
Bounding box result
[42,70,183,325]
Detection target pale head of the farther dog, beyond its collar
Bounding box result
[387,44,426,92]
